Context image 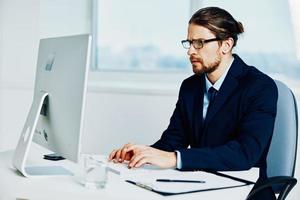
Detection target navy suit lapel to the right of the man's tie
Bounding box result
[204,55,246,129]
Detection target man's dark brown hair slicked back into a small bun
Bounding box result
[189,7,244,46]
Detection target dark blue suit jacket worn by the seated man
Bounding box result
[152,55,278,183]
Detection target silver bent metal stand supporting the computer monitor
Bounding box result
[13,91,73,177]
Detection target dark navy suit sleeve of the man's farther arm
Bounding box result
[151,82,188,151]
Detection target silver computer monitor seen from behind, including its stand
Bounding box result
[13,34,91,177]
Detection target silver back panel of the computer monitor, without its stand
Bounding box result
[34,35,89,161]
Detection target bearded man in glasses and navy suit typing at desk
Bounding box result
[109,7,278,199]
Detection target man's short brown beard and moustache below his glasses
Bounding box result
[190,53,221,74]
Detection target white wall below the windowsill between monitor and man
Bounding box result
[83,90,176,153]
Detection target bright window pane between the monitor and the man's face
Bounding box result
[93,0,190,71]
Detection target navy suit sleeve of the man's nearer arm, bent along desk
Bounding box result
[179,81,278,171]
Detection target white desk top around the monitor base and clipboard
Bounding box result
[0,144,258,200]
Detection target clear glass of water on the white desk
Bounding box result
[84,155,108,189]
